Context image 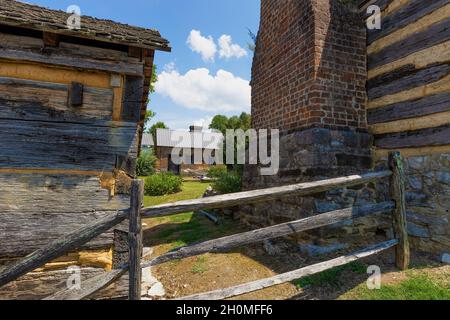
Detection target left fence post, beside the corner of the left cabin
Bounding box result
[128,180,144,300]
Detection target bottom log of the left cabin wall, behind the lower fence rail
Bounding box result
[0,267,128,300]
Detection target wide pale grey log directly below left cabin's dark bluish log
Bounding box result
[0,173,129,258]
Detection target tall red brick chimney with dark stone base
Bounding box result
[241,0,384,245]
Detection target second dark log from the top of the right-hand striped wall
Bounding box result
[368,17,450,70]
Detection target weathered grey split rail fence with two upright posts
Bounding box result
[0,152,410,300]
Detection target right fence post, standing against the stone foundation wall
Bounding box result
[389,152,410,270]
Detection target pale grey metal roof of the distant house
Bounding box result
[142,129,223,150]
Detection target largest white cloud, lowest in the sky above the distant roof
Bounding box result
[155,68,251,113]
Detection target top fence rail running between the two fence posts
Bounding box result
[142,171,392,218]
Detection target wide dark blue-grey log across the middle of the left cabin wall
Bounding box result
[0,119,137,172]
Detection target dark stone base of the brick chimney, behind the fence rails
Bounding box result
[240,128,392,247]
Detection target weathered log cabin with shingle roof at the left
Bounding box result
[0,0,171,299]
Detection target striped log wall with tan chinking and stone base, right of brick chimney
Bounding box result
[361,0,450,252]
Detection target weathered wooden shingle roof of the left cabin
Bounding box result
[0,0,171,51]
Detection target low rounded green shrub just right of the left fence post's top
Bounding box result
[145,172,183,196]
